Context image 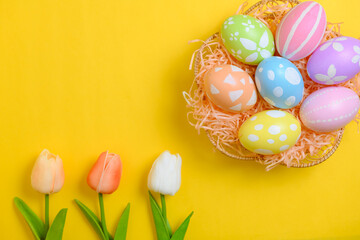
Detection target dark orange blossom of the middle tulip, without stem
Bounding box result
[87,151,122,194]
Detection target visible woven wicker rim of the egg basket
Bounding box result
[194,0,344,168]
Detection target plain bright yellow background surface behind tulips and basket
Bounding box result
[0,0,360,240]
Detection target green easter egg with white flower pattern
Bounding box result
[221,15,275,65]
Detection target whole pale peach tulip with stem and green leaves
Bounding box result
[14,149,67,240]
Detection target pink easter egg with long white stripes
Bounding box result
[276,1,326,61]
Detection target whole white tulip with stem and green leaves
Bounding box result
[148,151,193,240]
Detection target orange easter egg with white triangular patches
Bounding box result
[204,65,257,112]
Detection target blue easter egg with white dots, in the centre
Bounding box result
[255,57,304,109]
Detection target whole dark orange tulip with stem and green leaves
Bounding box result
[75,151,130,240]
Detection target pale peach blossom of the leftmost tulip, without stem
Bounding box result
[31,149,65,194]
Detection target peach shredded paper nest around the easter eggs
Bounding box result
[184,0,360,170]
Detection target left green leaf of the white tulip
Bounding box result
[149,191,170,240]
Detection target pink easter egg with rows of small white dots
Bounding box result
[300,87,360,132]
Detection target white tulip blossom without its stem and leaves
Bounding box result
[148,151,181,196]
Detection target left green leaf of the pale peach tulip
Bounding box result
[14,197,46,240]
